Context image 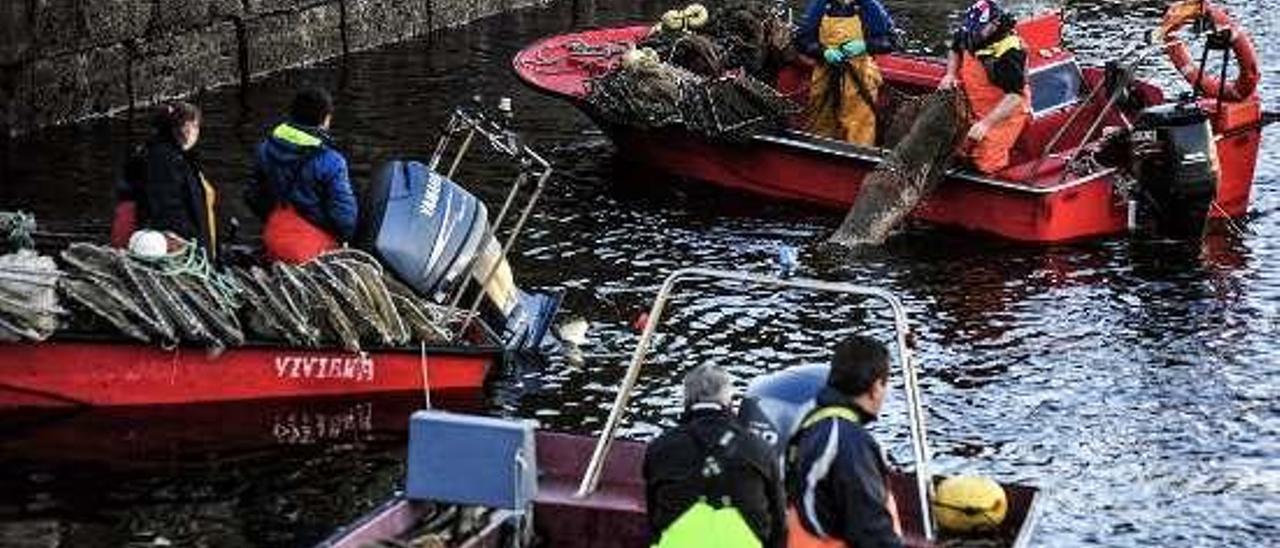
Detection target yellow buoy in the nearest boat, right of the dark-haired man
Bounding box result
[933,476,1009,533]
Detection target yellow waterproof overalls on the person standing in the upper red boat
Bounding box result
[809,15,882,146]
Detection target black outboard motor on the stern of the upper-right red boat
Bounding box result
[1130,102,1219,238]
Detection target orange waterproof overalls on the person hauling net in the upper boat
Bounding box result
[960,35,1032,173]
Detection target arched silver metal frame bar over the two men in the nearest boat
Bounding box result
[575,268,934,540]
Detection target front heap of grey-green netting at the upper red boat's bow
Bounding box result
[586,50,797,141]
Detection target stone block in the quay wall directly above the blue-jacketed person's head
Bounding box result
[247,4,342,76]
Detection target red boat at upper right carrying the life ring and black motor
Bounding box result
[513,6,1270,243]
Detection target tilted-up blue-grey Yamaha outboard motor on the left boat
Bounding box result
[356,160,559,351]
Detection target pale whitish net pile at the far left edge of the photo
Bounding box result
[0,211,67,342]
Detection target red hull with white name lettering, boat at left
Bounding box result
[0,341,503,408]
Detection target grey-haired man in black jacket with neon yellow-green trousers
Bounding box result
[644,364,786,548]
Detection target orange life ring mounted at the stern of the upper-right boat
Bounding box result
[1153,0,1261,101]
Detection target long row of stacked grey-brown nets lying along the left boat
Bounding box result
[58,243,476,352]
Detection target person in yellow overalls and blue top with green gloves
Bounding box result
[796,0,896,146]
